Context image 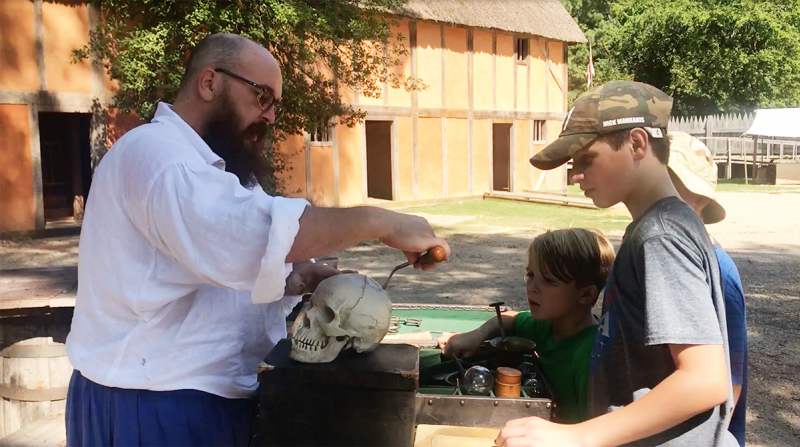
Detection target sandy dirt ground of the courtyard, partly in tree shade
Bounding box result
[0,193,800,447]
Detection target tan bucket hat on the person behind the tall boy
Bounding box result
[667,131,725,224]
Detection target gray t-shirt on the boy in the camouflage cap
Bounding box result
[589,197,737,447]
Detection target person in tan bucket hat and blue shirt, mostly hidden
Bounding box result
[668,131,748,447]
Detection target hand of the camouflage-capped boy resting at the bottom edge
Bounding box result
[495,417,584,447]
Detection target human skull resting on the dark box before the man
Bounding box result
[289,274,392,363]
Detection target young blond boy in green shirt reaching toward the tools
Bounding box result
[439,228,614,423]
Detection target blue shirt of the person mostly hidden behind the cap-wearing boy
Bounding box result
[714,243,747,447]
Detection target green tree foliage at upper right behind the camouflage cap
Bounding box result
[562,0,800,115]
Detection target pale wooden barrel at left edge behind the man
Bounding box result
[0,309,72,437]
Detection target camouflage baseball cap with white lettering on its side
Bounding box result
[531,81,672,169]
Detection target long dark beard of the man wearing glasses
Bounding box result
[202,94,271,188]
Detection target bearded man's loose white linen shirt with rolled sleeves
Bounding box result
[67,103,308,398]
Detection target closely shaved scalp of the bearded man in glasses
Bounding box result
[181,34,254,90]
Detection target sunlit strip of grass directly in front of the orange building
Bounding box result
[403,200,631,234]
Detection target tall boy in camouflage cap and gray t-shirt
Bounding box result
[497,81,737,447]
